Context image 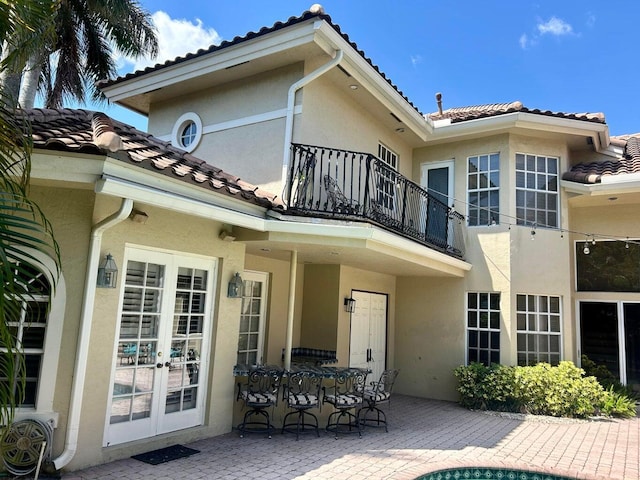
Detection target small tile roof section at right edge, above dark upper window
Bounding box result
[562,134,640,184]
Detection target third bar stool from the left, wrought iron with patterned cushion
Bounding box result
[322,368,368,439]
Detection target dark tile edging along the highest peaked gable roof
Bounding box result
[98,9,422,115]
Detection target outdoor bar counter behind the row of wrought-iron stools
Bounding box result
[233,363,371,433]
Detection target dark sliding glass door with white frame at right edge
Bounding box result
[580,302,640,390]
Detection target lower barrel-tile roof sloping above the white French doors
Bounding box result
[23,109,282,208]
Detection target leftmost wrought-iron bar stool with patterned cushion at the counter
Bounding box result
[236,367,283,438]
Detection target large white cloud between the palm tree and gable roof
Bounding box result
[116,11,222,70]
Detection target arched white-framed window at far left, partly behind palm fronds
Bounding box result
[0,250,66,412]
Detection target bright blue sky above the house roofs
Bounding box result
[102,0,640,135]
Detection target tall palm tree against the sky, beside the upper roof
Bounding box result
[20,0,158,108]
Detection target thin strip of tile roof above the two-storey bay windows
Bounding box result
[427,101,605,123]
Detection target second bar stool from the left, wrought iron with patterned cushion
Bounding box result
[282,371,322,440]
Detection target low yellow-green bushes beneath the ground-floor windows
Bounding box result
[454,361,635,417]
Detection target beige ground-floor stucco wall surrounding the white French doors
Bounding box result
[56,197,244,469]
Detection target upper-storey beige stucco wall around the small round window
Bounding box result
[149,63,303,195]
